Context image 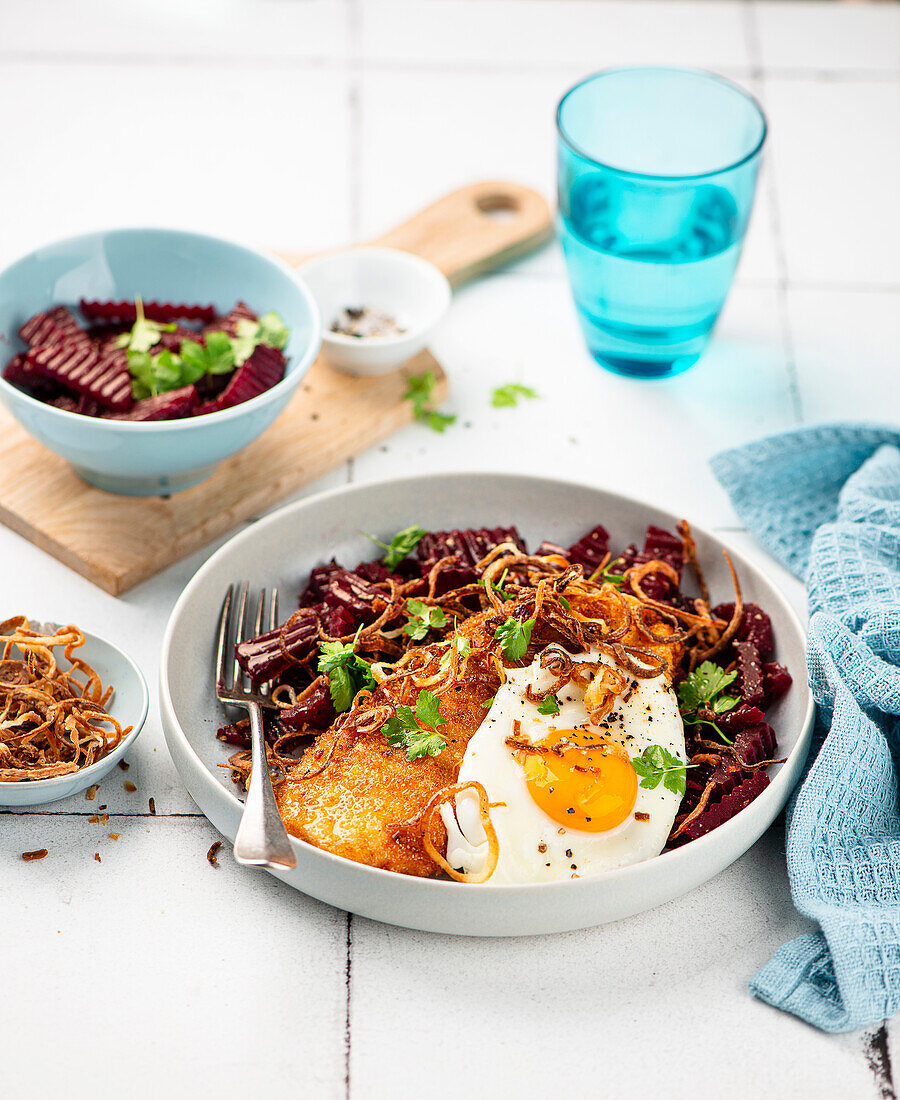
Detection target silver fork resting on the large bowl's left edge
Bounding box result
[216,581,297,869]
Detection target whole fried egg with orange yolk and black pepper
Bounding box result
[441,650,687,883]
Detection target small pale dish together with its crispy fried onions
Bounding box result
[0,615,150,806]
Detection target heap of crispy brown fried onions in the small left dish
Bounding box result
[0,615,133,783]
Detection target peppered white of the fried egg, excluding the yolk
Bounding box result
[441,650,687,883]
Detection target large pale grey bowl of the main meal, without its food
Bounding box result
[160,474,813,936]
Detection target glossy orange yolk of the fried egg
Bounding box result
[514,729,637,833]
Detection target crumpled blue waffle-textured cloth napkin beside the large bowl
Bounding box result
[712,425,900,1032]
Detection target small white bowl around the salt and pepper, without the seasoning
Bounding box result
[297,246,451,375]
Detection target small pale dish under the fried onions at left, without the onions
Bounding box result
[0,631,150,809]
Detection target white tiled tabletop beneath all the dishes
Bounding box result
[0,0,900,1100]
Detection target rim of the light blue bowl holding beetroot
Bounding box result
[0,226,322,432]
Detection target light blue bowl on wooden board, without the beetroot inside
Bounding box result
[0,229,321,496]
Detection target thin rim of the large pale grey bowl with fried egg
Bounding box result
[160,471,815,900]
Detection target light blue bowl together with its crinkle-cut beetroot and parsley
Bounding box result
[0,229,321,496]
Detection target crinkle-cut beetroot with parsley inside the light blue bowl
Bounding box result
[3,297,289,421]
